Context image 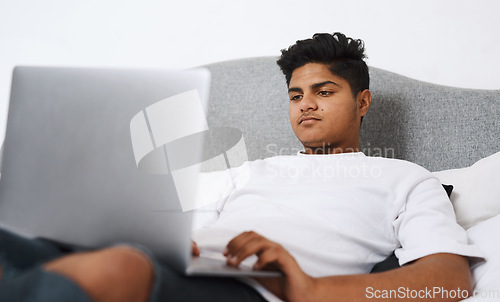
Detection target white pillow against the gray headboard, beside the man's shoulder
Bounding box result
[433,152,500,229]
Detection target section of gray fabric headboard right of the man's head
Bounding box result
[368,68,500,171]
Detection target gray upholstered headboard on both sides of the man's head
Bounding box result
[201,57,500,171]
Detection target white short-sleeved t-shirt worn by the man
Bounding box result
[193,152,481,300]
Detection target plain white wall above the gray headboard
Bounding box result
[0,0,500,139]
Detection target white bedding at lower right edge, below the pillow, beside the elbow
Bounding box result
[467,215,500,301]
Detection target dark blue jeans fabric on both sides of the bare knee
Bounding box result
[0,229,265,302]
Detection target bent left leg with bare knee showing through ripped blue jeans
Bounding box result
[0,229,153,302]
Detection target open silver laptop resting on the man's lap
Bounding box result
[0,67,277,276]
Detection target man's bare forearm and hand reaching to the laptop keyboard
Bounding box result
[225,232,471,302]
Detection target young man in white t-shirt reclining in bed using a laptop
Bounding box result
[0,33,481,301]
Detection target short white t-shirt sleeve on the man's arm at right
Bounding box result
[393,175,483,265]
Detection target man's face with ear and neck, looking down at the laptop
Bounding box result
[288,63,371,153]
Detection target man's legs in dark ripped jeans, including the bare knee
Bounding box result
[0,230,265,302]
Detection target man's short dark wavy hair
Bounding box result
[277,32,370,96]
